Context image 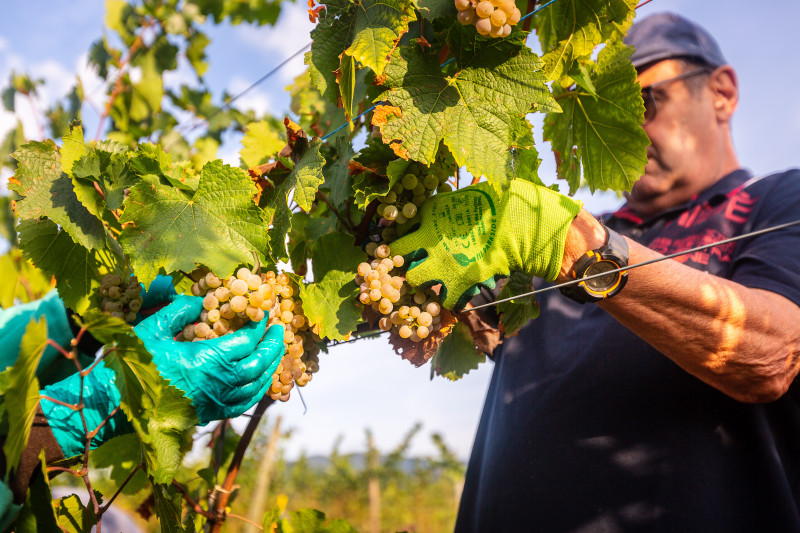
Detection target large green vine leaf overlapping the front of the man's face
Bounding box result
[544,44,650,192]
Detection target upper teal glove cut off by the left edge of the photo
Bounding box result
[0,290,72,377]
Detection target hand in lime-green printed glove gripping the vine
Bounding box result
[391,179,581,310]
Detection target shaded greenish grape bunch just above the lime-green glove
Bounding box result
[378,161,455,229]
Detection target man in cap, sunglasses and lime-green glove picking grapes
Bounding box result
[392,14,800,533]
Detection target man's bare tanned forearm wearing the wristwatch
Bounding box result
[562,210,800,402]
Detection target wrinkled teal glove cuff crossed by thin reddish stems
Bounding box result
[39,361,133,457]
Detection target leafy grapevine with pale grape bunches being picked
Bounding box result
[0,0,648,531]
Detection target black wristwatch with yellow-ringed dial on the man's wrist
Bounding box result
[559,226,628,304]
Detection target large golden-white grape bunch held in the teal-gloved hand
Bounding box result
[178,267,320,402]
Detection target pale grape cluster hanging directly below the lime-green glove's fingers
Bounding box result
[356,242,442,342]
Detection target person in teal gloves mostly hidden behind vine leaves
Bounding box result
[0,282,284,531]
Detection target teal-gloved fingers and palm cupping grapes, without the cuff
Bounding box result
[134,296,284,424]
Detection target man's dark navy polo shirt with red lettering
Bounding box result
[456,170,800,533]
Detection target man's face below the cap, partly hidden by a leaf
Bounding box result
[628,60,721,216]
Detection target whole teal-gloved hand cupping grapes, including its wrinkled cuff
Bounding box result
[41,296,284,457]
